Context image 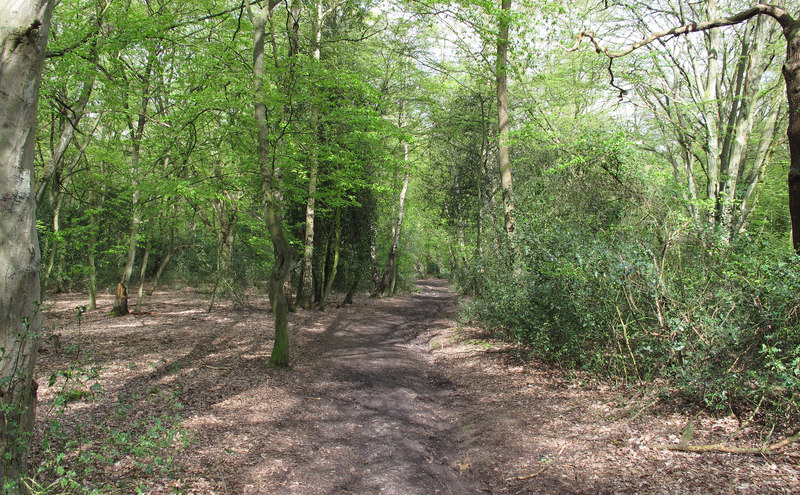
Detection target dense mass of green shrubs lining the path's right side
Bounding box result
[462,119,800,425]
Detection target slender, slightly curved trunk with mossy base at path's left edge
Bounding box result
[248,2,294,368]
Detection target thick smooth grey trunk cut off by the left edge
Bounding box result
[0,0,53,488]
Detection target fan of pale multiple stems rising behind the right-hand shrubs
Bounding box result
[601,0,781,242]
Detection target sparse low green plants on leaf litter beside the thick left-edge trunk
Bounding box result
[25,308,192,495]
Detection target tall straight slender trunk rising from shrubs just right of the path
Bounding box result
[495,0,517,240]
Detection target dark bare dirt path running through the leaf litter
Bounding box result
[266,280,485,495]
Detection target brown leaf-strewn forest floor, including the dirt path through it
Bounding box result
[32,280,800,495]
